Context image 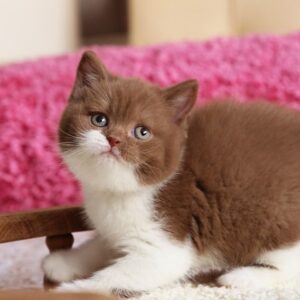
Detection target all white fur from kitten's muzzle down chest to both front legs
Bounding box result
[43,130,223,292]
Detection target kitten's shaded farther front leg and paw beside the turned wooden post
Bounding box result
[42,237,109,282]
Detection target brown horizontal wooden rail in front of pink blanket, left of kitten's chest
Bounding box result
[0,205,92,243]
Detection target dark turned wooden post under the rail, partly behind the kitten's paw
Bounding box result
[44,233,74,289]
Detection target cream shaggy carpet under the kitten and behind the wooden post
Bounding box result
[0,233,300,300]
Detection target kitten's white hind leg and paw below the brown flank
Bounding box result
[218,242,300,288]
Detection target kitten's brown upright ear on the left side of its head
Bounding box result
[71,51,112,99]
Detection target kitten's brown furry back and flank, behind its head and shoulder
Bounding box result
[186,101,300,264]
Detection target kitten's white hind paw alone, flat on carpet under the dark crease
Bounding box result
[217,267,276,289]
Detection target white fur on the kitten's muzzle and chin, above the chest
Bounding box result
[63,130,140,192]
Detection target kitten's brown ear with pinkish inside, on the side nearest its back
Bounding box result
[163,80,198,124]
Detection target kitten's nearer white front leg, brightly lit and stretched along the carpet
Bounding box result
[58,243,192,293]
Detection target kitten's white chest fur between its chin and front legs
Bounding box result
[84,188,164,246]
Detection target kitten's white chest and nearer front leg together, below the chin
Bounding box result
[51,185,194,292]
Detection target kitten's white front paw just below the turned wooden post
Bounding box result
[42,250,78,282]
